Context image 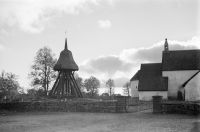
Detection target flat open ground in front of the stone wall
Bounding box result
[0,112,200,132]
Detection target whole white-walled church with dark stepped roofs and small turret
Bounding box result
[130,39,200,101]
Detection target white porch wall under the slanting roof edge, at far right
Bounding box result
[185,73,200,101]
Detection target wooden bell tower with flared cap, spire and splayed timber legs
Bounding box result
[49,38,83,98]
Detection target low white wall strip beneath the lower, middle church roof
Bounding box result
[139,91,167,101]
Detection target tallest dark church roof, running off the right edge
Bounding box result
[162,50,200,71]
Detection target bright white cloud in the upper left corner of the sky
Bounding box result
[0,0,102,33]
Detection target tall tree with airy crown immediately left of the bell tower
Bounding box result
[29,46,57,95]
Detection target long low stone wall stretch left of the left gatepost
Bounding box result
[0,101,119,112]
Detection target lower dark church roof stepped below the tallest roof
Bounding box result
[138,63,168,91]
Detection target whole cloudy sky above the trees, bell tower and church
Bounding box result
[0,0,200,93]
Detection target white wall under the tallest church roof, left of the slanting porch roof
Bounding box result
[162,70,198,98]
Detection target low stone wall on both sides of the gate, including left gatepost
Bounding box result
[0,97,200,115]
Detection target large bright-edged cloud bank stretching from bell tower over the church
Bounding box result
[79,36,200,87]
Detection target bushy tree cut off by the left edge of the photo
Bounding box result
[0,71,20,99]
